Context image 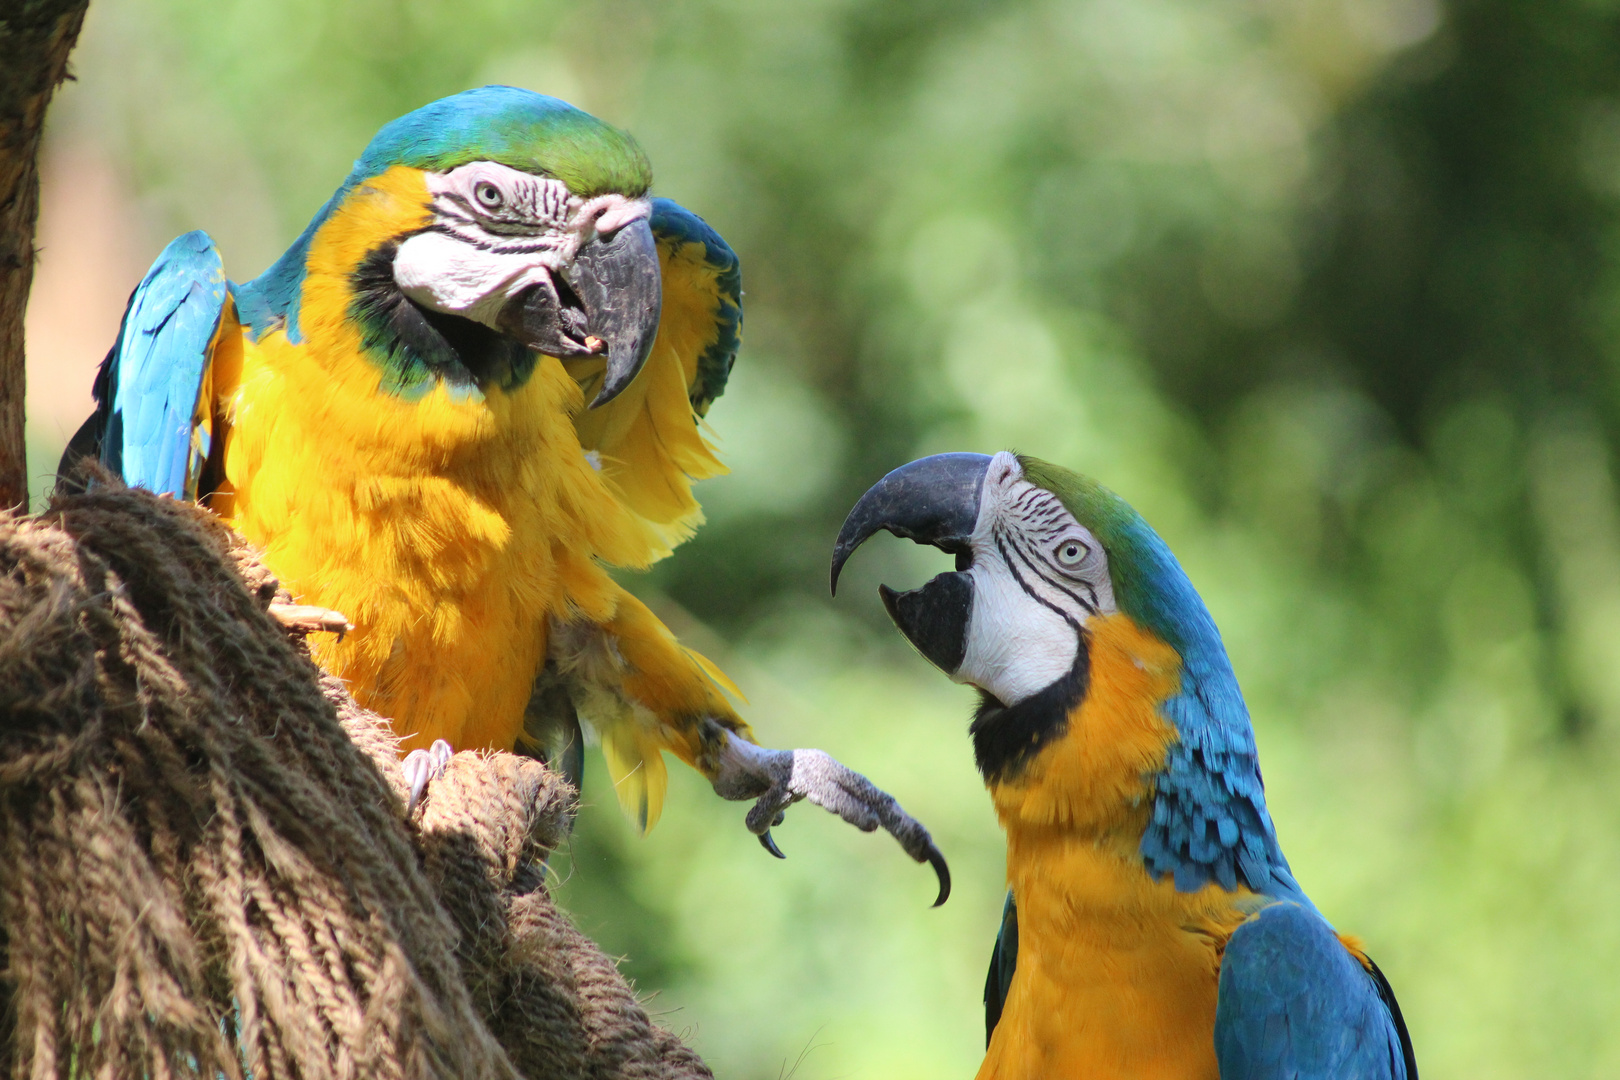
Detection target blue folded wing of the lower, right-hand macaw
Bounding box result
[1215,902,1418,1080]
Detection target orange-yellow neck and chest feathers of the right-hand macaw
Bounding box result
[978,615,1254,1080]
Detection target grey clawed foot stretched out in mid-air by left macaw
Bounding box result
[714,735,951,907]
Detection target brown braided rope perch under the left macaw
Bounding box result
[0,486,710,1080]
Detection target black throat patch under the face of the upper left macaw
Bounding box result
[348,236,539,398]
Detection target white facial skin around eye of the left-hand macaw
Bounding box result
[394,162,653,327]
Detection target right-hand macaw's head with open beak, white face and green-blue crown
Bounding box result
[833,452,1230,706]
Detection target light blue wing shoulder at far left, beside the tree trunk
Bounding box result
[97,232,230,497]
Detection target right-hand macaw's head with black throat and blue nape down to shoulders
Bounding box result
[833,452,1311,907]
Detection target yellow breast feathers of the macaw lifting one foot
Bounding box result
[219,167,670,748]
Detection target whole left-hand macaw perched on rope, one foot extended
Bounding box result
[62,86,948,899]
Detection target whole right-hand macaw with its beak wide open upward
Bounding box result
[833,452,1418,1080]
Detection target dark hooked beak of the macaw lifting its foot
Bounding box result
[499,217,664,408]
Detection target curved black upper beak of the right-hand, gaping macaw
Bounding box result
[833,453,990,596]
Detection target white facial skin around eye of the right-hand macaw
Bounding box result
[953,450,1115,704]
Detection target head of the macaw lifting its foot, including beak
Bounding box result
[238,86,661,405]
